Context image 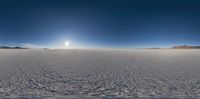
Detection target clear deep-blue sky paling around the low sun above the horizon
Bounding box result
[0,0,200,48]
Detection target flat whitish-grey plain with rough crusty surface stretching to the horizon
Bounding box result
[0,49,200,99]
